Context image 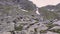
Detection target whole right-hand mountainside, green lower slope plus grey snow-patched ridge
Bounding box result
[38,4,60,20]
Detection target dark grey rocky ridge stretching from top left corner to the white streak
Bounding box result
[1,0,36,11]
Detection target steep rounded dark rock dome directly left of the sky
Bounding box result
[17,0,36,11]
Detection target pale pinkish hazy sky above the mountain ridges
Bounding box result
[30,0,60,7]
